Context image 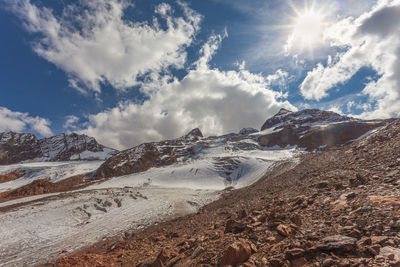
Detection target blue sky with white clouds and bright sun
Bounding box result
[0,0,400,149]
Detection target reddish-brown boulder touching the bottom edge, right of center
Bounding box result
[219,241,251,266]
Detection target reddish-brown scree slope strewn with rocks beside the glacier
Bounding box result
[45,120,400,266]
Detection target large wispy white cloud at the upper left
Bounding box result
[5,0,201,92]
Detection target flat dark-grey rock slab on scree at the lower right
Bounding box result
[316,235,357,253]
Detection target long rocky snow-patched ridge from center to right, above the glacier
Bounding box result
[96,109,386,181]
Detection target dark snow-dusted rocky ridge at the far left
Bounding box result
[0,132,117,165]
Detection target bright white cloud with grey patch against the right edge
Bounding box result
[300,0,400,118]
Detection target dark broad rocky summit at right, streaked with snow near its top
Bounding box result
[258,109,388,151]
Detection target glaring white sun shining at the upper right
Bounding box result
[285,2,328,54]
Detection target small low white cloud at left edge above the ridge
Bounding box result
[0,107,53,136]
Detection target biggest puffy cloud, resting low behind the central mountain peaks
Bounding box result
[83,35,296,149]
